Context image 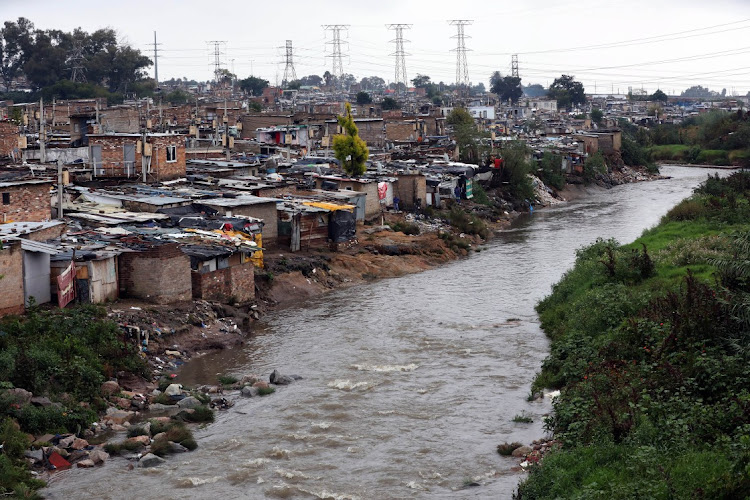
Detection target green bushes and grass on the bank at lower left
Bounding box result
[0,306,147,498]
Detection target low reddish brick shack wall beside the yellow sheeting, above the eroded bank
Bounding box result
[192,262,255,303]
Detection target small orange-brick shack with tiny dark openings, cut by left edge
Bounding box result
[0,180,52,223]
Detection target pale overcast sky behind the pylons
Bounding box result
[0,0,750,95]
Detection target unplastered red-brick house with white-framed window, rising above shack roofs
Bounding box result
[89,133,185,182]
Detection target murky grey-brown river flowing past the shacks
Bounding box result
[44,167,732,500]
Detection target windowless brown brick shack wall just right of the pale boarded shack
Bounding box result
[119,243,193,304]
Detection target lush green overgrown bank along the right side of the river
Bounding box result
[518,173,750,499]
